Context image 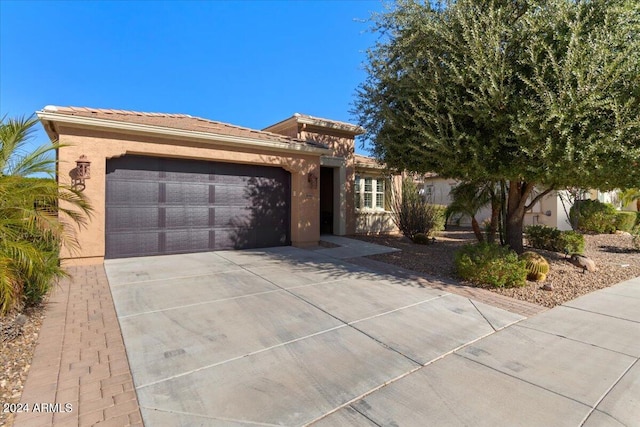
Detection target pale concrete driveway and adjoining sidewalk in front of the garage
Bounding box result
[105,247,640,426]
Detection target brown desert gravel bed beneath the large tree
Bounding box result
[357,229,640,307]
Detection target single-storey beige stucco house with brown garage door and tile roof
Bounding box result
[37,106,392,264]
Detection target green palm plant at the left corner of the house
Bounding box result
[0,116,91,314]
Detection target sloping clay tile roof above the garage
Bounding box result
[45,106,327,148]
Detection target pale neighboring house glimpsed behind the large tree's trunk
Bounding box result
[422,174,618,230]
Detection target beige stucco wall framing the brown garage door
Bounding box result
[58,126,320,264]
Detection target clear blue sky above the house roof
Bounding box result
[0,0,384,153]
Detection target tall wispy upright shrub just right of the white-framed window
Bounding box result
[391,178,445,240]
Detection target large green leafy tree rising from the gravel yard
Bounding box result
[354,0,640,252]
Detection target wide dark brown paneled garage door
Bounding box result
[106,156,291,258]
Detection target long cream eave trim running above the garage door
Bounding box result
[36,111,332,155]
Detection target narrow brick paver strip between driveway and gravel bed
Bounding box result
[347,258,548,317]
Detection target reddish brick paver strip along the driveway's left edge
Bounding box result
[14,264,142,427]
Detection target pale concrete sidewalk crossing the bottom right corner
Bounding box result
[344,278,640,427]
